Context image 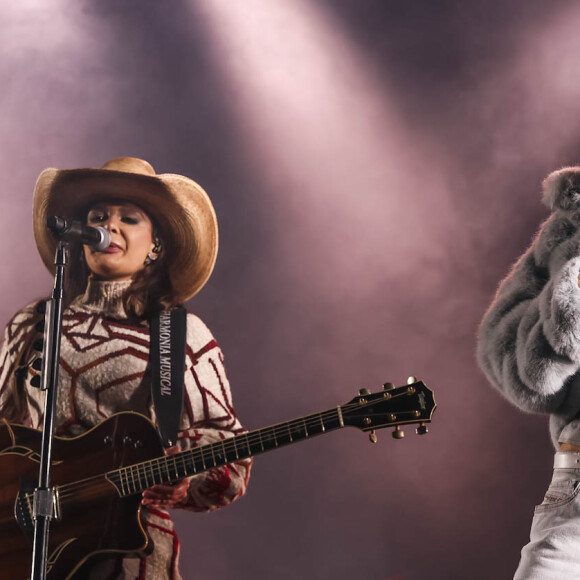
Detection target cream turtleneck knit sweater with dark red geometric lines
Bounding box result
[0,280,251,580]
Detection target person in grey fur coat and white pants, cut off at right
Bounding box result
[477,167,580,580]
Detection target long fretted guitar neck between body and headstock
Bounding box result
[106,407,344,496]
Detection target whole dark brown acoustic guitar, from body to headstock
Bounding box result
[0,377,436,580]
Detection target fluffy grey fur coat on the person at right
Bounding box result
[477,167,580,446]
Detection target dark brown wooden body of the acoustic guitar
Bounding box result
[0,413,164,580]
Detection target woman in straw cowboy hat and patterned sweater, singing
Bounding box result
[0,157,251,580]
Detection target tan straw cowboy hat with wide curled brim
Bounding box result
[33,157,218,302]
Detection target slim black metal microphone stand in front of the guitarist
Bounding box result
[30,241,67,580]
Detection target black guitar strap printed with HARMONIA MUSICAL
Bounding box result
[149,306,187,447]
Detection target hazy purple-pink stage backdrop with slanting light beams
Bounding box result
[0,0,580,580]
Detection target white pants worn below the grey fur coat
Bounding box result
[514,468,580,580]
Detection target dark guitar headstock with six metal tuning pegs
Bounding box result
[340,377,437,443]
